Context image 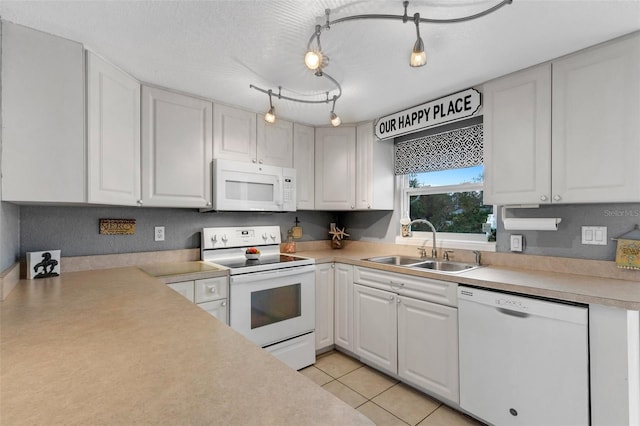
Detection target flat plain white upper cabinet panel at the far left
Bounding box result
[2,21,86,203]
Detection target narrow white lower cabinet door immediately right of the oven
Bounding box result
[316,263,334,351]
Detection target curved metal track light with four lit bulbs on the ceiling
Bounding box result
[249,0,513,126]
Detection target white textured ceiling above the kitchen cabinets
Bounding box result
[0,0,640,125]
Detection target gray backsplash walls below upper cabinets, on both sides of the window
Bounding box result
[12,203,640,262]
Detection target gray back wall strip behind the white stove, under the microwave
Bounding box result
[20,206,336,256]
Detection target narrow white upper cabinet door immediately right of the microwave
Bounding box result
[293,123,315,210]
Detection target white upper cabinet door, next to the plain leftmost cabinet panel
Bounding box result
[87,52,140,206]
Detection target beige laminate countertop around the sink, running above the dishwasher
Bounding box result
[296,249,640,310]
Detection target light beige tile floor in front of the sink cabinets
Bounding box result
[300,351,482,426]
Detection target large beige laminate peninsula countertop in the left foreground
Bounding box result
[0,267,371,425]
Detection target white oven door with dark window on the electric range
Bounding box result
[229,265,316,346]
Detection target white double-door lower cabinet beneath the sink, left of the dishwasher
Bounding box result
[350,267,460,404]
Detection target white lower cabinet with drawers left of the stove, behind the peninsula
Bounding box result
[167,277,229,324]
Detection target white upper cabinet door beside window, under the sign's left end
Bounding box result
[356,122,394,210]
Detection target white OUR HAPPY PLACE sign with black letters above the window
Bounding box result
[375,89,482,139]
